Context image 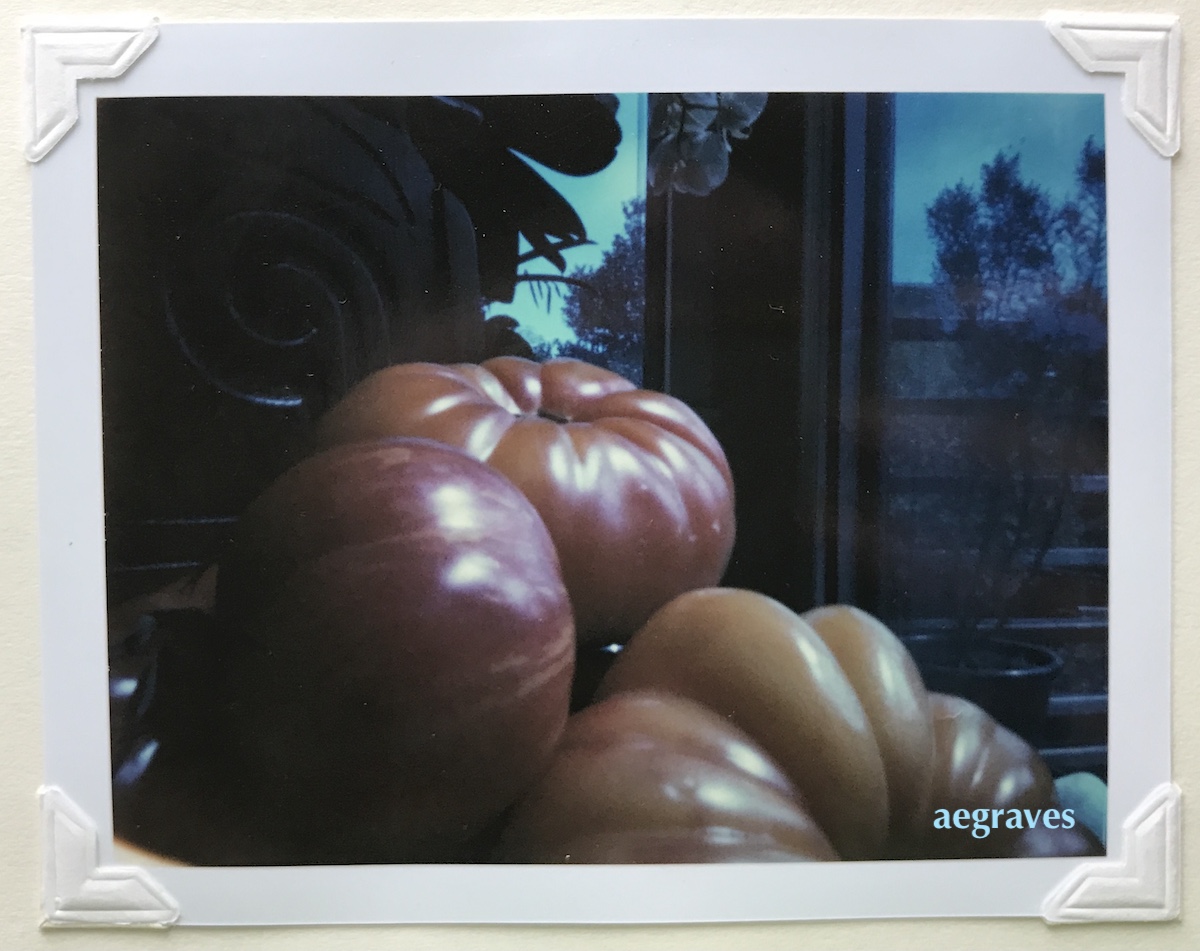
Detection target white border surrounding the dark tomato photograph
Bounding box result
[32,18,1171,925]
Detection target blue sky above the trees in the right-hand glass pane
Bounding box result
[892,94,1104,283]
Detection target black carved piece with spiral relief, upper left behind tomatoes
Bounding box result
[97,97,484,521]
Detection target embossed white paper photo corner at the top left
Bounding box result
[22,19,158,162]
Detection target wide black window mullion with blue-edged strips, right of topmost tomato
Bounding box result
[646,94,893,609]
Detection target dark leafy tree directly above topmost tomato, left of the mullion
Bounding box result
[539,198,646,382]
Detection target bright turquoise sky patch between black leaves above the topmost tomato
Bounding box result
[486,95,646,343]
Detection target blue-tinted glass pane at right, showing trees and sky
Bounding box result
[880,95,1108,749]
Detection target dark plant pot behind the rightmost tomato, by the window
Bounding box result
[905,634,1062,743]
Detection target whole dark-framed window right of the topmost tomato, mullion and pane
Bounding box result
[647,94,1108,774]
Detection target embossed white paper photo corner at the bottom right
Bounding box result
[1042,783,1182,925]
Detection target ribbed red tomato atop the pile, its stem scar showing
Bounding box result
[317,357,733,642]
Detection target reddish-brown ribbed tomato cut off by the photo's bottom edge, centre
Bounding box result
[494,692,838,865]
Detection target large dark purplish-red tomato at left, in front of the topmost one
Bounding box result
[217,439,575,862]
